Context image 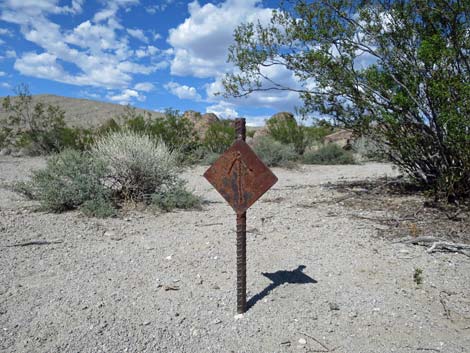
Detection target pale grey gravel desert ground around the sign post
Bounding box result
[0,157,470,353]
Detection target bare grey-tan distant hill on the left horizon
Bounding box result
[0,94,164,127]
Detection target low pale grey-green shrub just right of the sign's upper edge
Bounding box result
[253,136,299,168]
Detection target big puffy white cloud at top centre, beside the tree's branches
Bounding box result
[168,0,271,78]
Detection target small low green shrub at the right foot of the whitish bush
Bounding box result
[151,182,202,212]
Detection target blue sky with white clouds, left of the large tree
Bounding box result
[0,0,300,125]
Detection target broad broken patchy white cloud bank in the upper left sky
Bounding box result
[0,0,163,93]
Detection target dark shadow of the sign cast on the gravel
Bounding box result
[247,265,317,308]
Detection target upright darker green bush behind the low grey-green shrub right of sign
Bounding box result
[266,113,306,154]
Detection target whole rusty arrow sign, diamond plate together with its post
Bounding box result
[204,118,277,314]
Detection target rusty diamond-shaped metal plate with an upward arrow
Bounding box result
[204,140,277,214]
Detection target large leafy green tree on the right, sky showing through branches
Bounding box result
[224,0,470,201]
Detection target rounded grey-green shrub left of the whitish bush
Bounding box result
[23,150,111,212]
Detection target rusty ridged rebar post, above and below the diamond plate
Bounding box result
[235,118,246,314]
